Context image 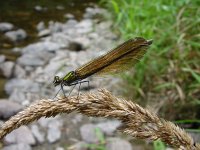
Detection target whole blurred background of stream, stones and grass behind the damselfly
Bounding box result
[0,0,200,150]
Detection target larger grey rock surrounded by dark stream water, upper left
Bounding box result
[5,29,27,42]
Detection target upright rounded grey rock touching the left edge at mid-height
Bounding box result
[0,61,15,78]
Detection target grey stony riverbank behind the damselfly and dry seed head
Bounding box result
[0,3,139,150]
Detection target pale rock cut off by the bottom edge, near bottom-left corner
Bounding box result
[2,143,32,150]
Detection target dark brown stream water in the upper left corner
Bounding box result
[0,0,99,98]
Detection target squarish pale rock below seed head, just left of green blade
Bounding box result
[80,124,99,143]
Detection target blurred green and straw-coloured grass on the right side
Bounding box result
[102,0,200,120]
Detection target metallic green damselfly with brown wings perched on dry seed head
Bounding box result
[53,37,152,96]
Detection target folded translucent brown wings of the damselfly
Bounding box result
[75,37,151,79]
